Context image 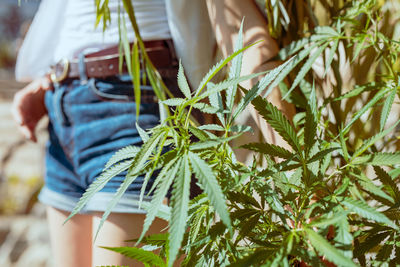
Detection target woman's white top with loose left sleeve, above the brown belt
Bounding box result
[16,0,171,81]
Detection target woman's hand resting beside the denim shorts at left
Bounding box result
[12,77,52,142]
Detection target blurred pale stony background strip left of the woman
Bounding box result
[0,0,51,267]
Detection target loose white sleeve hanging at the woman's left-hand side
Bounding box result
[15,0,67,82]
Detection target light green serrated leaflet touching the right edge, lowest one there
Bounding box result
[342,198,398,229]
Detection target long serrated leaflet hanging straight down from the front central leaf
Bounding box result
[168,155,191,266]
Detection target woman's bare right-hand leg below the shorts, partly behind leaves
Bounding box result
[92,212,168,267]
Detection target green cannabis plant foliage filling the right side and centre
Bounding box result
[76,0,400,266]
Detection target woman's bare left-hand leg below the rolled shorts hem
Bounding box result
[47,207,92,267]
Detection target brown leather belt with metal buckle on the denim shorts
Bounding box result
[50,39,178,83]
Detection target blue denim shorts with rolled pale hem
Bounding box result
[39,77,159,213]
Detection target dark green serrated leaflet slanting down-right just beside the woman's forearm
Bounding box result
[252,96,300,152]
